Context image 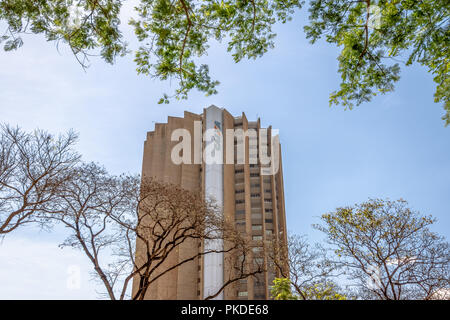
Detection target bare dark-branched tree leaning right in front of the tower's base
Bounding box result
[130,175,263,300]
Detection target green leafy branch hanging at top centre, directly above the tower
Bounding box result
[131,0,301,103]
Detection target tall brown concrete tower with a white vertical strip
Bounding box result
[133,106,287,300]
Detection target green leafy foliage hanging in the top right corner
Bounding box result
[305,0,450,125]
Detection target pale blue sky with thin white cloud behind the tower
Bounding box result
[0,5,450,299]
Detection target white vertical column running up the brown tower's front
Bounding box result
[203,106,224,300]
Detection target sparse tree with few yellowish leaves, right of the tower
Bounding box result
[316,199,450,300]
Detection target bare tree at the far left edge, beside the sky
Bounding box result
[0,125,80,236]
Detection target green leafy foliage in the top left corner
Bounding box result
[0,0,126,67]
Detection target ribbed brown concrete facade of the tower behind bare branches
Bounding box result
[133,106,287,299]
